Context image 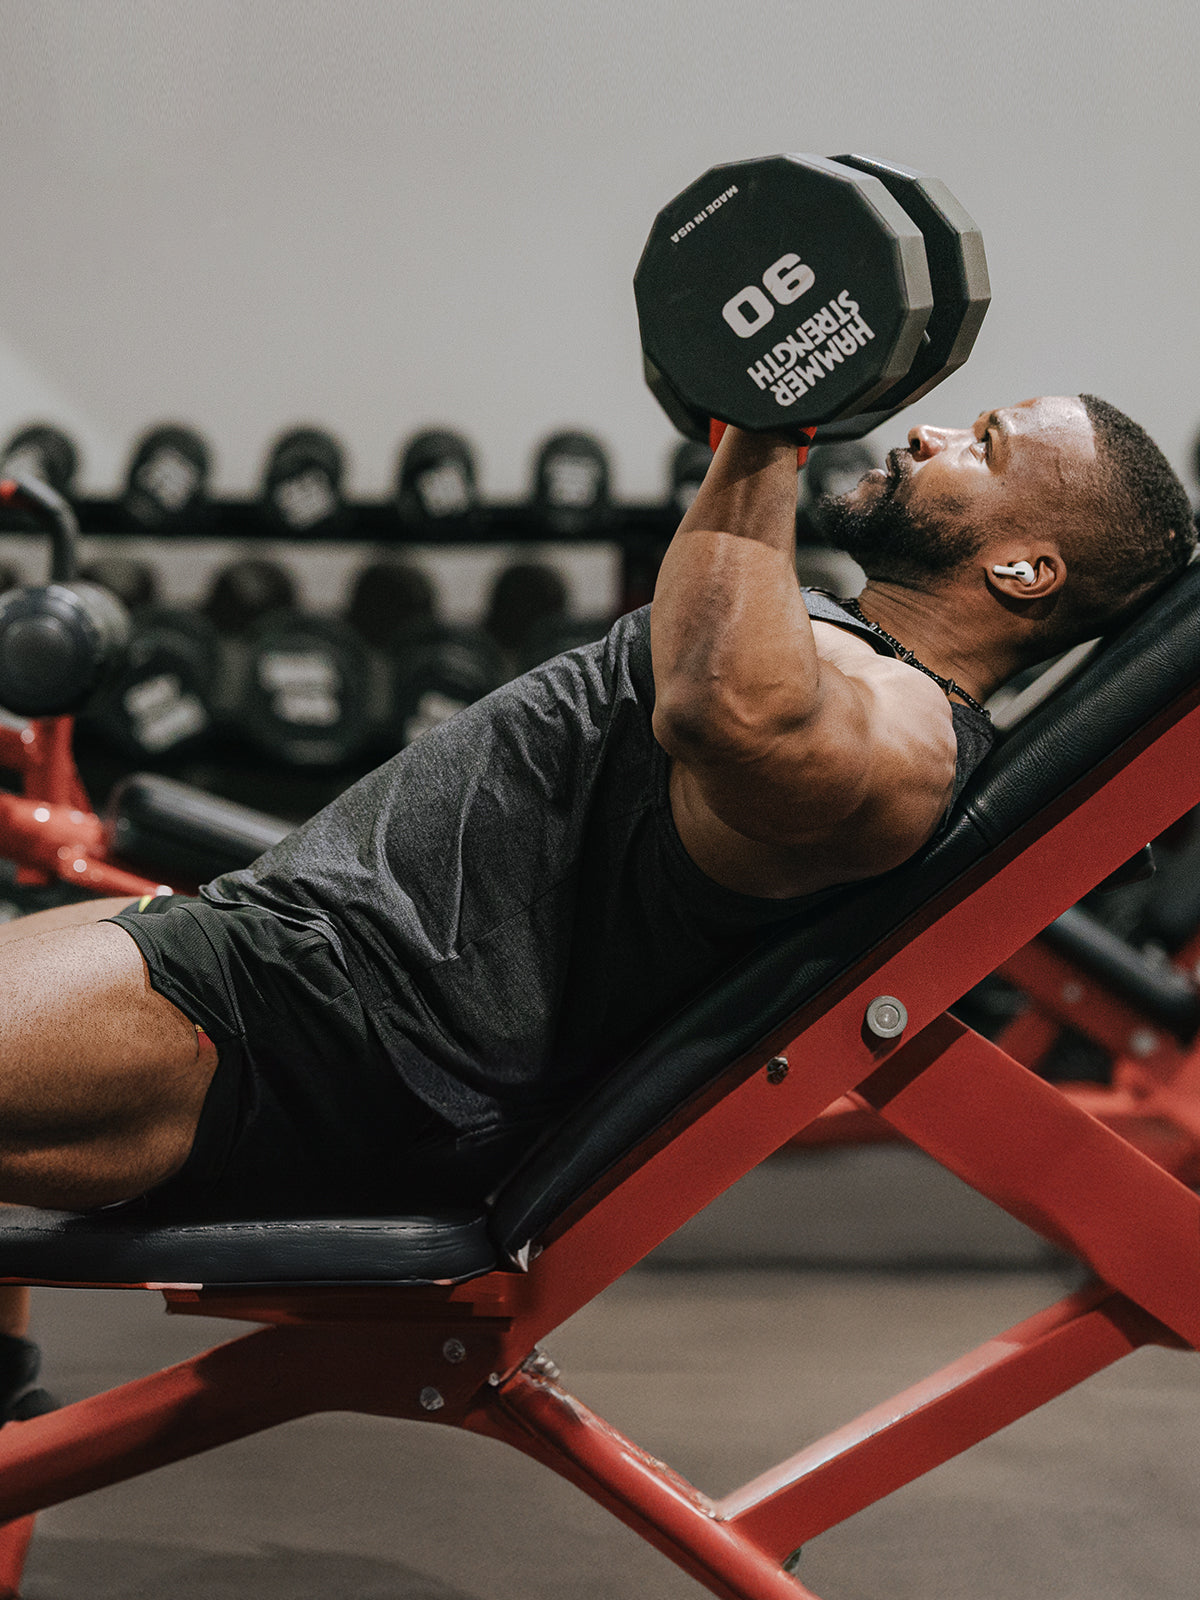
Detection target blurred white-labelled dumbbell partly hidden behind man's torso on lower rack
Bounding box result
[390,622,506,746]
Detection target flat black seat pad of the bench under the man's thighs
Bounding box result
[0,1208,498,1288]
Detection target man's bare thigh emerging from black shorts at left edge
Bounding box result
[0,912,216,1210]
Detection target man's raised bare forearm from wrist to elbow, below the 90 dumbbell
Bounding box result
[651,429,818,742]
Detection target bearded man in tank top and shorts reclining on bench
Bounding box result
[0,395,1194,1420]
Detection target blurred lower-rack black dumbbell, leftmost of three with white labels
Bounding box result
[83,606,221,765]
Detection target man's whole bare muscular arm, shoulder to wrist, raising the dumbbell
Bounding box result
[651,429,955,896]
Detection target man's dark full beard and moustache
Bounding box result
[818,450,984,589]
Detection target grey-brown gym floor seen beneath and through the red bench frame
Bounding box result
[11,1150,1200,1600]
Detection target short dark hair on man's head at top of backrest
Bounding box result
[1064,395,1195,638]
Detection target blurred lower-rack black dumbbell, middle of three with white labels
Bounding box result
[235,611,374,766]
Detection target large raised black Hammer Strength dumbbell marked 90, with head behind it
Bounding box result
[634,155,990,440]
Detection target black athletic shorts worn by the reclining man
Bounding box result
[110,894,528,1221]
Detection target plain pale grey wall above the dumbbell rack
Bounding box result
[0,0,1200,498]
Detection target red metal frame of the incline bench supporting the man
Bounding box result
[0,686,1200,1600]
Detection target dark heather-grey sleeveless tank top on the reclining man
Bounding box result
[202,590,990,1131]
